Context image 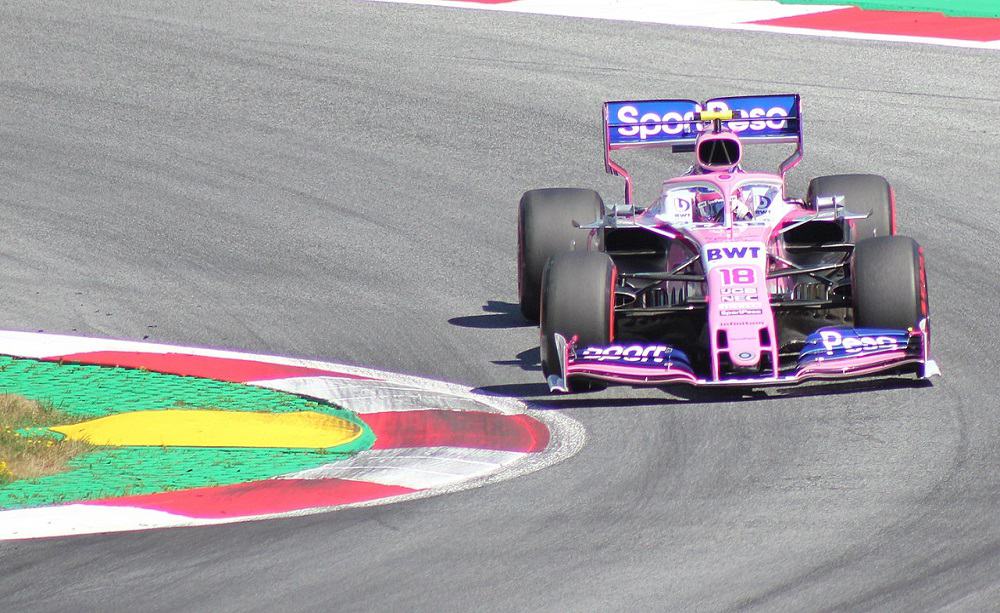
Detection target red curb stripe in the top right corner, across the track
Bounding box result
[751,8,1000,42]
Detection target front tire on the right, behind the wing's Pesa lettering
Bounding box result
[851,236,928,330]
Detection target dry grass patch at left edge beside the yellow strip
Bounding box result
[0,394,92,486]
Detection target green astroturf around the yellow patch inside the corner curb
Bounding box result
[0,356,375,509]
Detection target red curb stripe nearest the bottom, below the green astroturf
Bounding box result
[85,479,419,519]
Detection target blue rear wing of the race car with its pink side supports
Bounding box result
[604,94,802,204]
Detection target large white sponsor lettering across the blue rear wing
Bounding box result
[618,102,788,140]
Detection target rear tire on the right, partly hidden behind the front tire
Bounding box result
[807,175,896,243]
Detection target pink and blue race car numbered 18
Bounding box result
[518,94,940,392]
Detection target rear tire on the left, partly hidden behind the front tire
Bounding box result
[517,187,604,323]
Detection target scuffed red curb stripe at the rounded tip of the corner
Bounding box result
[360,409,549,453]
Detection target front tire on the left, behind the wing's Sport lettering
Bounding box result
[540,252,618,392]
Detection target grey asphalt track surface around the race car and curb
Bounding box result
[0,1,1000,611]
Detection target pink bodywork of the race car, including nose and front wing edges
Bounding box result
[550,116,937,391]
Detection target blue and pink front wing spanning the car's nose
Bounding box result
[548,319,941,392]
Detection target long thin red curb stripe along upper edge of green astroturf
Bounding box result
[43,351,377,383]
